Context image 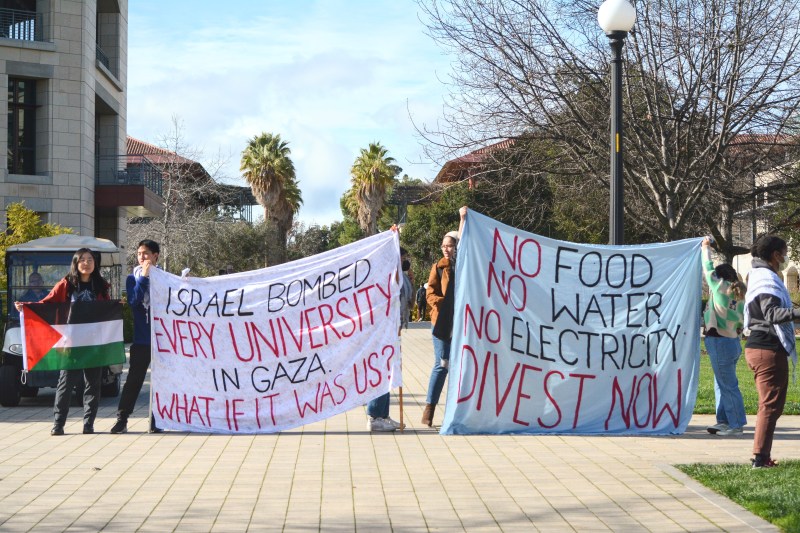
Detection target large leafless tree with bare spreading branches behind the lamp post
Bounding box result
[419,0,800,251]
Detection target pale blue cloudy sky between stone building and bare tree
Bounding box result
[127,0,450,224]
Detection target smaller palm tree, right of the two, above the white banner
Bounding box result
[350,143,403,236]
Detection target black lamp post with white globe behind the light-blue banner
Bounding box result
[597,0,636,244]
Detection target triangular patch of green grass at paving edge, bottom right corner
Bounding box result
[677,461,800,533]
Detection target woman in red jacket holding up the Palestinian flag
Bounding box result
[14,248,109,436]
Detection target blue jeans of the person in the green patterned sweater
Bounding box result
[706,337,747,428]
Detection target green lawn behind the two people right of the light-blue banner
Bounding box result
[694,343,800,416]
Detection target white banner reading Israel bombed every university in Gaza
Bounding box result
[150,231,400,433]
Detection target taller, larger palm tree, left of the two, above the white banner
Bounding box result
[240,133,303,263]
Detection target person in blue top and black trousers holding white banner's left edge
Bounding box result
[111,239,161,434]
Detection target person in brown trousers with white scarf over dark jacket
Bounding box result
[744,235,800,468]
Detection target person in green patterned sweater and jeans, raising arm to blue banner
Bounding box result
[701,237,747,436]
